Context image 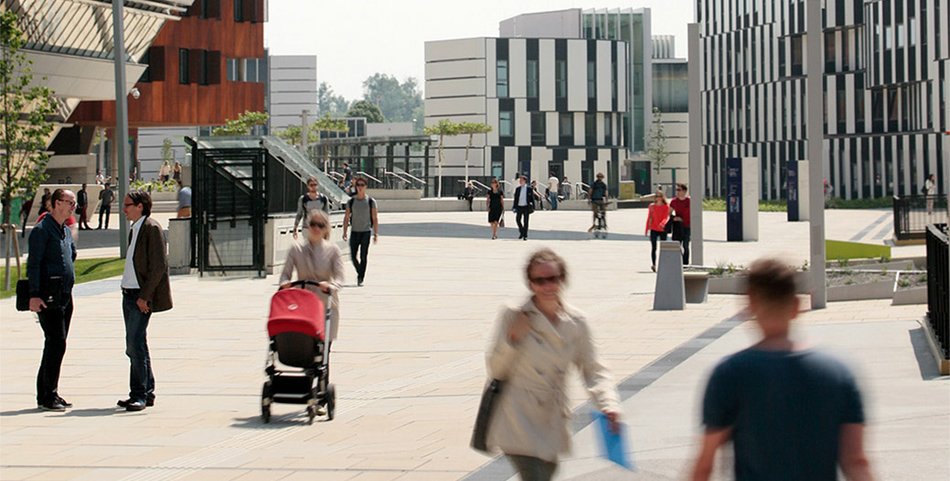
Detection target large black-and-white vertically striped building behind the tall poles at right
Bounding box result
[695,0,950,199]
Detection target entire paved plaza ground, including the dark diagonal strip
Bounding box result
[0,210,950,481]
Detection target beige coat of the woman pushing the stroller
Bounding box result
[279,241,343,341]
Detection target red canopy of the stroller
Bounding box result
[267,288,325,341]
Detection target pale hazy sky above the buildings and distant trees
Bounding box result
[264,0,693,100]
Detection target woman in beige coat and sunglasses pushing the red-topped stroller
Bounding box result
[280,210,343,342]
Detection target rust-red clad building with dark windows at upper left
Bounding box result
[66,0,267,182]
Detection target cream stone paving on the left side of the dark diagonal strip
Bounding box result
[0,210,936,480]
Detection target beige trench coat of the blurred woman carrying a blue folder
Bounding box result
[487,298,620,462]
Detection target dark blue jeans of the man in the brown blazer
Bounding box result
[122,289,155,401]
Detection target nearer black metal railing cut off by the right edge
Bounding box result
[927,224,950,359]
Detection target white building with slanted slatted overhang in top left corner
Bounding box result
[0,0,193,182]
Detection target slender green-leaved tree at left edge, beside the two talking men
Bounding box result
[0,11,56,289]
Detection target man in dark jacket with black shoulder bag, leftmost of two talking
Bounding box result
[26,189,76,411]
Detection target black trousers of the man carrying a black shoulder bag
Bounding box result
[36,295,73,404]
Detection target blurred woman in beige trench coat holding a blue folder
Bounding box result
[487,249,620,481]
